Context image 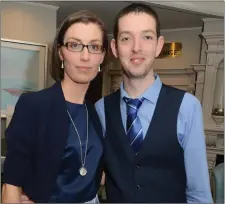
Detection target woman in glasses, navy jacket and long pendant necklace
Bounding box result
[2,11,108,203]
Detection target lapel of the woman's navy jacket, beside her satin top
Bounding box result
[42,83,69,183]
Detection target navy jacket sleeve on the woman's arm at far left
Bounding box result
[3,94,35,186]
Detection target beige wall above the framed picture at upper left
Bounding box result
[1,2,57,85]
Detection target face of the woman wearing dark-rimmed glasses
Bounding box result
[59,23,105,84]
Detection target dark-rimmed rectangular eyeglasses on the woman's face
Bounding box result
[64,42,104,54]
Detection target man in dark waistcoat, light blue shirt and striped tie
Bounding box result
[96,4,213,203]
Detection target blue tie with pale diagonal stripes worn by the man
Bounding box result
[123,97,144,153]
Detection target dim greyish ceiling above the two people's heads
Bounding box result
[39,1,221,33]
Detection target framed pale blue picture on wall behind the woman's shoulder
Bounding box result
[1,38,48,118]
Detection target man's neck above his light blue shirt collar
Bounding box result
[123,73,155,98]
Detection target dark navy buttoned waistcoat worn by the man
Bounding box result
[104,85,186,203]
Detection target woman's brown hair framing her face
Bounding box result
[50,10,108,82]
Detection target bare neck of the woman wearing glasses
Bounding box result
[61,75,89,104]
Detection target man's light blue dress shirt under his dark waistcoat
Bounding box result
[95,75,213,203]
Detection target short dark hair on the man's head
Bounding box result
[113,3,160,40]
